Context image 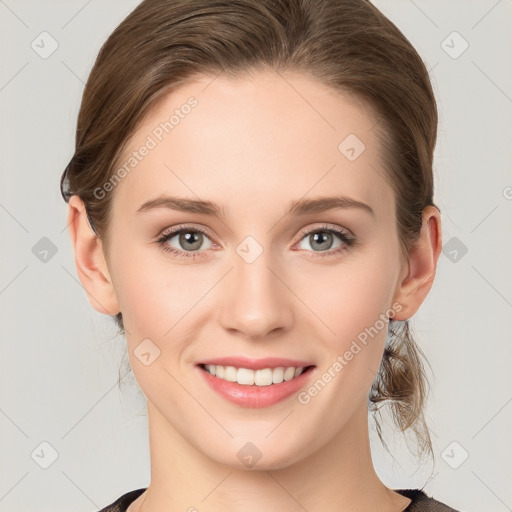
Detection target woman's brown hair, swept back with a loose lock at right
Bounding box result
[61,0,437,453]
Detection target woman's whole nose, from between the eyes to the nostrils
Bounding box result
[221,242,291,338]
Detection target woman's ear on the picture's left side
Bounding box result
[68,195,121,316]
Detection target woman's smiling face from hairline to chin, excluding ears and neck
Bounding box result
[81,72,416,468]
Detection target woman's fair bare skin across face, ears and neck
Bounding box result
[68,71,441,512]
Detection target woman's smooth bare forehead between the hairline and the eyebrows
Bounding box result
[114,71,393,222]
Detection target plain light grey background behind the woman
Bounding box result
[0,0,512,512]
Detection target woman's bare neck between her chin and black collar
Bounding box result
[129,402,410,512]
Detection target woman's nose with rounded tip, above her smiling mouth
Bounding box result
[219,251,294,340]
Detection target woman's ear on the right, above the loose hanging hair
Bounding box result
[393,206,442,320]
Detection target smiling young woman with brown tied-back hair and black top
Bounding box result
[61,0,460,512]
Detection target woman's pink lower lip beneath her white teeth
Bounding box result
[196,366,315,409]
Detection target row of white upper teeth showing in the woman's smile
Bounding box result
[205,364,304,386]
